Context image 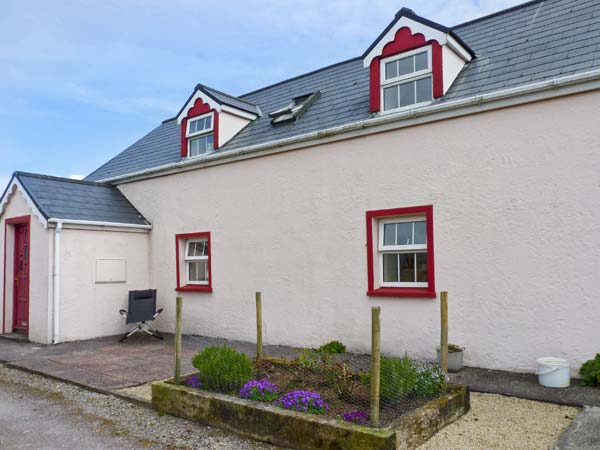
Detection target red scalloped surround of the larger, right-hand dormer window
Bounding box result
[369,27,444,112]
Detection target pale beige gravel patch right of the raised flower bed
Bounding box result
[418,392,579,450]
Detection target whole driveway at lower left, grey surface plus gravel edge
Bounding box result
[0,366,278,450]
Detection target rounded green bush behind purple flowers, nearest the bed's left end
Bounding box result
[192,346,253,393]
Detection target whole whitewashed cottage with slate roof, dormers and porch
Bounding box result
[0,0,600,371]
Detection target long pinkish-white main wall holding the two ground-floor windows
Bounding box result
[120,92,600,370]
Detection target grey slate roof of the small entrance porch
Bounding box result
[5,172,150,225]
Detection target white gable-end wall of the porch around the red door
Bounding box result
[0,190,52,344]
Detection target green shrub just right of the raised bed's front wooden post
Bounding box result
[380,356,417,400]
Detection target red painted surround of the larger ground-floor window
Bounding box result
[366,205,437,298]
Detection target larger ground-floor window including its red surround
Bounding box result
[367,206,436,297]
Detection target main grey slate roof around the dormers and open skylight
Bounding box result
[87,0,600,180]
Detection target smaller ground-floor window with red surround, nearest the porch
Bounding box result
[176,232,212,292]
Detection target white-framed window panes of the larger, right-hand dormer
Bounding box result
[380,46,433,112]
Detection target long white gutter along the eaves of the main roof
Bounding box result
[99,70,600,184]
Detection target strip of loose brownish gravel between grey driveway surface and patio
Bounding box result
[0,365,280,450]
